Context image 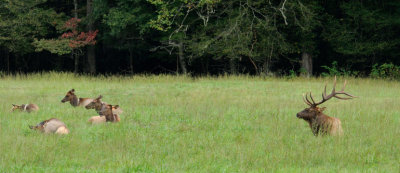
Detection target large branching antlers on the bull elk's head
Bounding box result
[303,76,356,106]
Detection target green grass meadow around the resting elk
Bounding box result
[0,73,400,172]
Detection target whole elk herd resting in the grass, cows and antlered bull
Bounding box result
[12,76,356,136]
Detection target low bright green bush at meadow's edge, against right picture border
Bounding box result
[370,63,400,80]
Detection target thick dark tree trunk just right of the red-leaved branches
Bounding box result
[86,0,96,74]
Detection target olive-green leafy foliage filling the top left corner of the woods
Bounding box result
[0,0,62,55]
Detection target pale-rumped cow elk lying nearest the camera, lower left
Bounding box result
[29,118,69,135]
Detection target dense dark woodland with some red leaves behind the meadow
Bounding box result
[0,0,400,76]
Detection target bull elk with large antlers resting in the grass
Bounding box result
[297,76,356,136]
